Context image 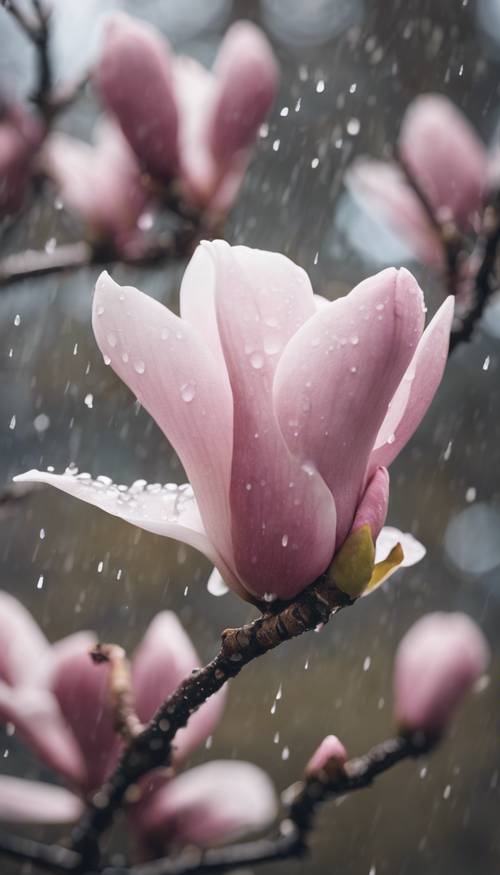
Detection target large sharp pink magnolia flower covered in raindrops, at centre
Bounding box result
[16,241,453,599]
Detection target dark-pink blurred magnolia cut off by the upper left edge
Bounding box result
[0,105,43,216]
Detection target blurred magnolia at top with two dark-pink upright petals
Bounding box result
[94,13,278,212]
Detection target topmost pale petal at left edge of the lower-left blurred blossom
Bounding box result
[0,591,49,686]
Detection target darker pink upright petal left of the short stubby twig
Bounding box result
[50,633,118,791]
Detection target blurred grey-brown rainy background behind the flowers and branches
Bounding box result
[0,0,500,875]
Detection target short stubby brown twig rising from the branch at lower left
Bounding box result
[90,644,144,744]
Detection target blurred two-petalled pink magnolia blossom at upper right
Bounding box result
[347,94,489,267]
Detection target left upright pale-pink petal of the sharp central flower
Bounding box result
[93,273,232,582]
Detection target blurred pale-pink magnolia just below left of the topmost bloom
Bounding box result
[41,120,149,251]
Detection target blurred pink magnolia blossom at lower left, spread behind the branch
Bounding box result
[0,592,276,846]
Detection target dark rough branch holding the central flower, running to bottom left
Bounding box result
[73,577,352,865]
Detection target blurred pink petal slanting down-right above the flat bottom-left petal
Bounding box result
[0,683,85,786]
